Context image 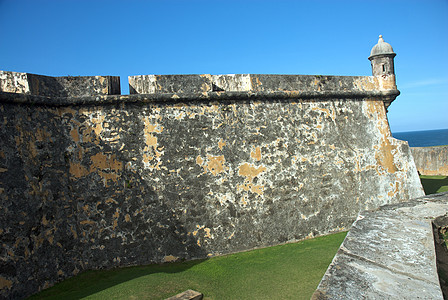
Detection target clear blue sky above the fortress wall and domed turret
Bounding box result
[0,0,448,132]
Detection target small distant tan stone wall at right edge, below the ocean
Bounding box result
[411,146,448,176]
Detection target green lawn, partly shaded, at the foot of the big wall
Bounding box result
[31,232,346,299]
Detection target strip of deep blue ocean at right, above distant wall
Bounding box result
[392,129,448,147]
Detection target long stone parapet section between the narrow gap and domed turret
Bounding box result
[129,74,400,106]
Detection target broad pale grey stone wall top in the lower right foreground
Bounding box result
[312,192,448,299]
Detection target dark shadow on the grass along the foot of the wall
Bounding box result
[28,259,207,299]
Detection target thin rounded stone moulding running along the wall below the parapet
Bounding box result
[0,90,400,106]
